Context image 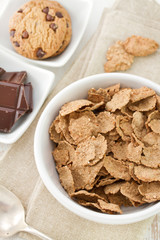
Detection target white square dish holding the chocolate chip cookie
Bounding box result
[0,0,92,67]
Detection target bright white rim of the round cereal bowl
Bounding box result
[34,73,160,225]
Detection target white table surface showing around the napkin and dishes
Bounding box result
[0,0,160,240]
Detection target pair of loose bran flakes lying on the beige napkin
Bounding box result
[104,35,159,73]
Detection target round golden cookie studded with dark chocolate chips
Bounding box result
[9,0,71,59]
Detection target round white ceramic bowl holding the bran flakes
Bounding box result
[34,73,160,224]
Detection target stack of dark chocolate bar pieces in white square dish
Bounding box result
[0,68,33,133]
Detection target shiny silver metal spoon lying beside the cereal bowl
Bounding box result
[0,185,53,240]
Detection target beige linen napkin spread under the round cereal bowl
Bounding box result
[0,0,160,240]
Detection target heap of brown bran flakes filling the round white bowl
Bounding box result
[49,83,160,214]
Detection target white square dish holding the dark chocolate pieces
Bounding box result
[0,47,55,144]
